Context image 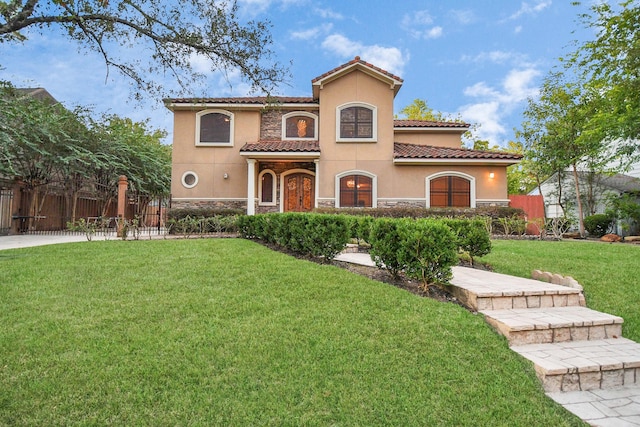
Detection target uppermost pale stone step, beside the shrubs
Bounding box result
[449,267,584,311]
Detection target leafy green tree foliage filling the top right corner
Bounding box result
[566,0,640,161]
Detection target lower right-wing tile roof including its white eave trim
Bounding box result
[393,142,522,165]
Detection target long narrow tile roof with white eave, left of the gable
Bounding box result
[163,96,318,109]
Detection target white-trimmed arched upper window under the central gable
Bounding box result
[336,104,377,142]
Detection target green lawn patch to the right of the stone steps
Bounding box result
[481,240,640,342]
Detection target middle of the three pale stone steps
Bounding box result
[481,306,623,346]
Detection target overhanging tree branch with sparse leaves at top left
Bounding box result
[0,0,288,98]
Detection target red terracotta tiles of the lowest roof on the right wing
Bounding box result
[393,142,522,161]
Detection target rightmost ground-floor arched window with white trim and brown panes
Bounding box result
[426,171,476,208]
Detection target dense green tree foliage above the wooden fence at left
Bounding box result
[0,86,171,220]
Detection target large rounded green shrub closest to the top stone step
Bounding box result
[398,219,458,290]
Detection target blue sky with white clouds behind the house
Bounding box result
[0,0,591,145]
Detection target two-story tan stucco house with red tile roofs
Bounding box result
[165,57,520,214]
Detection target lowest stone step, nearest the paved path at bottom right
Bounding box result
[511,338,640,393]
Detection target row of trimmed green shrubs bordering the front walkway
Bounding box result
[238,213,491,290]
